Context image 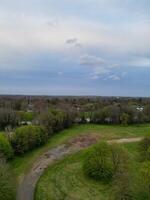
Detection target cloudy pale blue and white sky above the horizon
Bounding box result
[0,0,150,97]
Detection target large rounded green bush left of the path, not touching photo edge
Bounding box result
[11,125,48,154]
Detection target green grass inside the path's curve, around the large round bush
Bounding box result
[35,143,138,200]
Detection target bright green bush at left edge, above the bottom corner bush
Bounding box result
[0,133,13,160]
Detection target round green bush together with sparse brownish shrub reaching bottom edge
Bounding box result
[83,142,132,197]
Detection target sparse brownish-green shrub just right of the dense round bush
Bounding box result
[112,145,133,200]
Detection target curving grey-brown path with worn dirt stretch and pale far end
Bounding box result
[17,134,142,200]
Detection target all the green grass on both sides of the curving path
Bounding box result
[10,124,150,200]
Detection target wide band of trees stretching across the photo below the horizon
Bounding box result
[0,96,150,132]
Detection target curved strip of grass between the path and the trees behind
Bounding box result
[10,124,150,184]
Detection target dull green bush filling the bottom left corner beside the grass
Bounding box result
[0,162,16,200]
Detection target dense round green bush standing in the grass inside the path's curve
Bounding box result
[83,142,114,182]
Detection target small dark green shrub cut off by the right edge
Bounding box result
[139,137,150,161]
